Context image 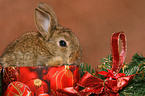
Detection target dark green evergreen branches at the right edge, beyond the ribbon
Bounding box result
[121,54,145,96]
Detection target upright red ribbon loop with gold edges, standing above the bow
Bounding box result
[111,32,127,73]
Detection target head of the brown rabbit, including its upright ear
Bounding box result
[35,3,81,64]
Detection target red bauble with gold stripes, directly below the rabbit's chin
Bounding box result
[43,65,79,94]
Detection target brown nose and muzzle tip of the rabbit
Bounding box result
[68,50,81,64]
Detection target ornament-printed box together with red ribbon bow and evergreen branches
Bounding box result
[1,32,145,96]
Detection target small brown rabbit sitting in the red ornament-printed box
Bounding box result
[0,3,81,67]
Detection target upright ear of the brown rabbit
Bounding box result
[35,3,58,40]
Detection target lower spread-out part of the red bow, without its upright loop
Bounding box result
[58,72,134,96]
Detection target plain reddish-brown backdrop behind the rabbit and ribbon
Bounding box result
[0,0,145,67]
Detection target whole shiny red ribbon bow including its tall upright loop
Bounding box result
[58,32,134,96]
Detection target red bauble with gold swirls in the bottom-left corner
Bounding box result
[4,81,34,96]
